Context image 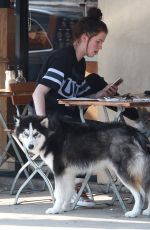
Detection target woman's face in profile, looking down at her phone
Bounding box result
[86,32,107,57]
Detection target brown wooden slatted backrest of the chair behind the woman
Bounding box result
[10,82,36,106]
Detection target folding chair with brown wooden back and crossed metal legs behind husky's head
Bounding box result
[10,82,54,204]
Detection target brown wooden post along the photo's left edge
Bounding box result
[0,8,16,154]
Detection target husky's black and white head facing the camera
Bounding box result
[15,116,49,154]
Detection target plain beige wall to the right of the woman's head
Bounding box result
[98,0,150,93]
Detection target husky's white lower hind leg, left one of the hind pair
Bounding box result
[118,175,143,217]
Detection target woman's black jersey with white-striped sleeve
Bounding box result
[39,46,90,99]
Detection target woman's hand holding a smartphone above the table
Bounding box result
[95,84,118,98]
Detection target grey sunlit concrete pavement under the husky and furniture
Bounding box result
[0,177,150,230]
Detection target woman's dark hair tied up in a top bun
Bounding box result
[73,7,108,41]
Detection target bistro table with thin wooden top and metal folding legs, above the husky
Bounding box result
[58,95,150,212]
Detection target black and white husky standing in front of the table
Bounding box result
[15,116,150,217]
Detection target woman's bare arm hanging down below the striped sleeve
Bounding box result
[32,84,50,116]
